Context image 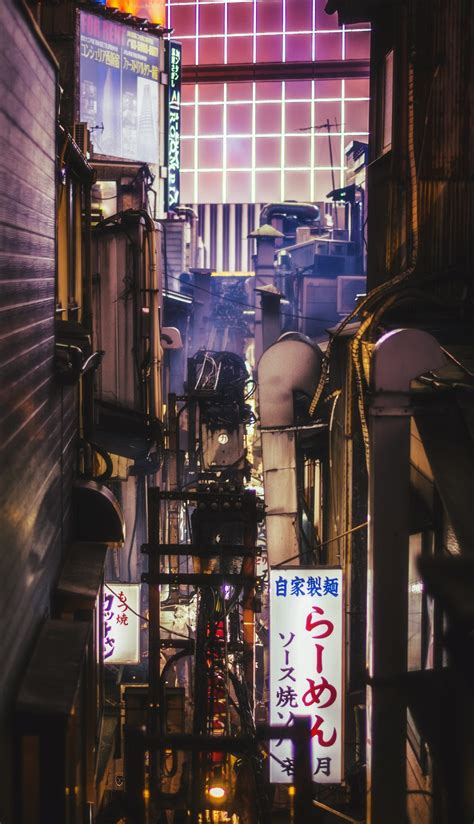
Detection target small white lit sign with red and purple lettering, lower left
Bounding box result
[102,582,140,664]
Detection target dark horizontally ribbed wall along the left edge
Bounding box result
[0,0,77,732]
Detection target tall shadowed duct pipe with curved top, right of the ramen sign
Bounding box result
[366,329,446,824]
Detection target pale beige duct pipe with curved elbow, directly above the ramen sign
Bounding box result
[258,332,322,566]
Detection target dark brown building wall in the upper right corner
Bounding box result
[368,0,474,296]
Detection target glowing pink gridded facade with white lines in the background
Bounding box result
[167,0,370,203]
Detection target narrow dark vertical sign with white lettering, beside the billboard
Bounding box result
[165,40,181,212]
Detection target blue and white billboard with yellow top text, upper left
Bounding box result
[79,12,160,164]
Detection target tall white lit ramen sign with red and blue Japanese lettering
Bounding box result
[270,567,344,784]
